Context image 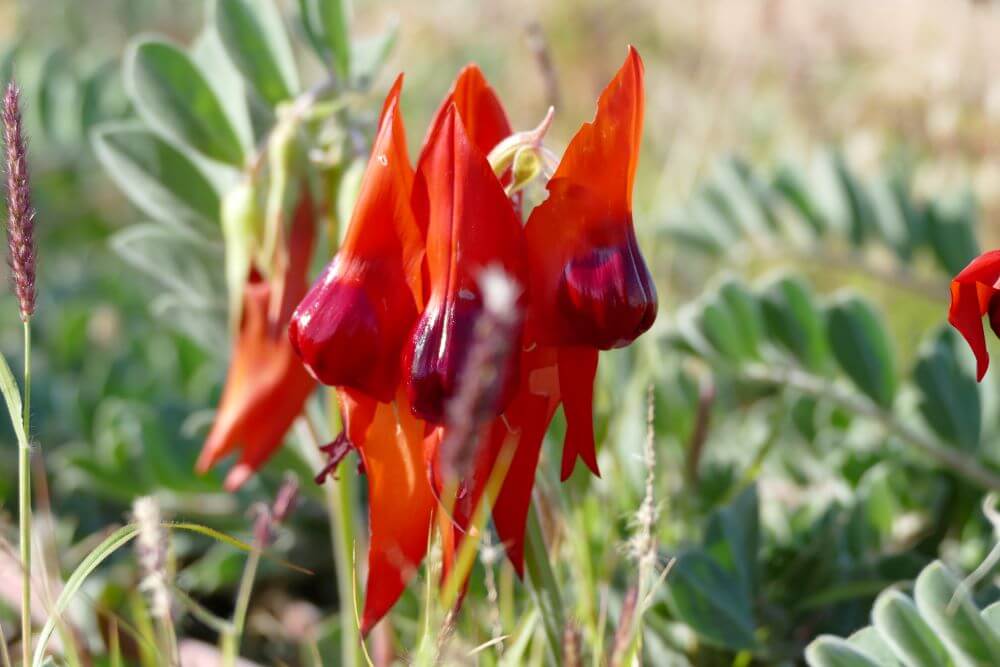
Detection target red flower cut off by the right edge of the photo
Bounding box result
[948,250,1000,380]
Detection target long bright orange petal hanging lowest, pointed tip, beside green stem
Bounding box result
[357,392,435,634]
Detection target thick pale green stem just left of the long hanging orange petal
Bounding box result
[323,470,361,667]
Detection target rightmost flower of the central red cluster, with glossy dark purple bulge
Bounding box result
[445,47,657,574]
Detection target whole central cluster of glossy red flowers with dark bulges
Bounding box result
[289,48,656,632]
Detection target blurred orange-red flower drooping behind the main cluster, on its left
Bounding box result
[196,185,316,491]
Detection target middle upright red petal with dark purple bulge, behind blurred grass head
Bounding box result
[404,106,526,423]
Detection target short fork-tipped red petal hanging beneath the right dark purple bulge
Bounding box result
[559,347,601,482]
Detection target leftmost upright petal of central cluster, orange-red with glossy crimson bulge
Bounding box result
[290,77,423,401]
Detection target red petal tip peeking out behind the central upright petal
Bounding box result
[424,63,513,155]
